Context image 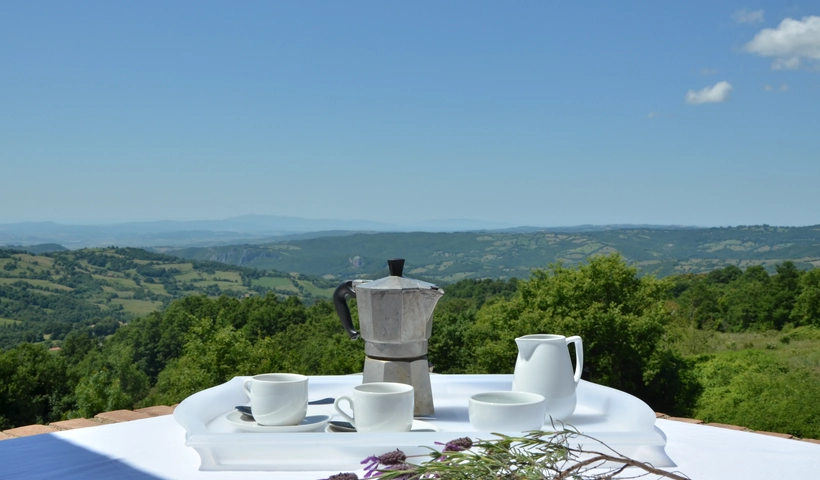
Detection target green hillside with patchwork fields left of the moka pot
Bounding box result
[0,247,335,348]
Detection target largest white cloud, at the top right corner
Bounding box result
[743,16,820,70]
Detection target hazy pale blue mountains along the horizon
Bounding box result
[0,215,693,249]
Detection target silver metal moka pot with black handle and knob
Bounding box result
[333,258,444,416]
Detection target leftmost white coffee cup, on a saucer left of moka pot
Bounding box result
[242,373,308,426]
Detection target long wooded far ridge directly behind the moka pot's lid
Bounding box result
[163,225,820,283]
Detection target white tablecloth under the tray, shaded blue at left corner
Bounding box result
[0,376,820,480]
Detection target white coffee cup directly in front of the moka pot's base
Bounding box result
[334,382,413,433]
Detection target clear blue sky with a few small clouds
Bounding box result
[0,0,820,226]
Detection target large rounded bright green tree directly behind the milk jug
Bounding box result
[468,254,696,412]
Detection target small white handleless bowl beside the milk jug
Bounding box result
[469,391,547,432]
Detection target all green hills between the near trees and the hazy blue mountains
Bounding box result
[6,226,820,348]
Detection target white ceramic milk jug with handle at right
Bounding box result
[512,334,584,421]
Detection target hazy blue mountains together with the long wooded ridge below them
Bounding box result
[0,215,820,284]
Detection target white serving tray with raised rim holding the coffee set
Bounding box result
[174,375,675,471]
